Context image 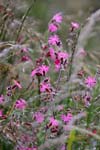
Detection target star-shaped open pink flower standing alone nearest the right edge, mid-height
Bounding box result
[85,76,96,88]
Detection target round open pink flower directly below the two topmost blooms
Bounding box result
[48,34,60,46]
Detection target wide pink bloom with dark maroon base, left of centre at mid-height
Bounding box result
[31,65,49,77]
